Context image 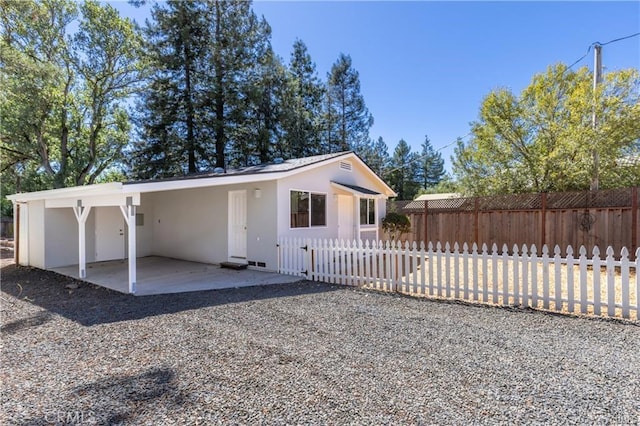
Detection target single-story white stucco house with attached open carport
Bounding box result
[8,152,395,293]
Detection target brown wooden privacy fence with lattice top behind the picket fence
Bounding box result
[398,187,640,258]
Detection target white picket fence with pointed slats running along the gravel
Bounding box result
[278,238,640,320]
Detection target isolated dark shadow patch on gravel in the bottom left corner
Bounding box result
[17,368,187,425]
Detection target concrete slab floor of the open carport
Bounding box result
[52,256,300,296]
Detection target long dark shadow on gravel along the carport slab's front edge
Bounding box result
[0,265,338,326]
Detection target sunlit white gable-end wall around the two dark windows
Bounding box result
[278,161,386,238]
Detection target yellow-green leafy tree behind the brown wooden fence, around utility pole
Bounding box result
[453,64,640,195]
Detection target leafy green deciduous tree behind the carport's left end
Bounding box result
[0,0,141,190]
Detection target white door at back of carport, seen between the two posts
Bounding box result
[94,207,125,262]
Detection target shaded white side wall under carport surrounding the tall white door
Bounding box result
[146,181,277,270]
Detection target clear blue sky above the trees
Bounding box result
[110,1,640,169]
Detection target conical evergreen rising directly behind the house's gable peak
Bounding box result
[325,54,373,153]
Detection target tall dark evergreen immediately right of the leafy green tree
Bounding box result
[131,0,210,179]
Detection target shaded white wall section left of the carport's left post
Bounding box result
[44,208,79,268]
